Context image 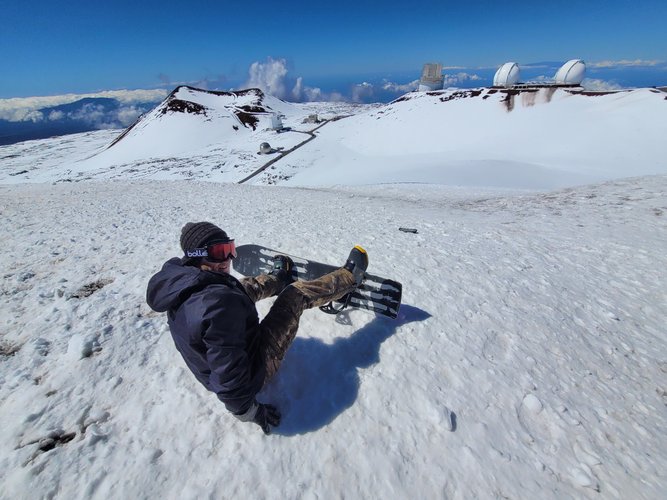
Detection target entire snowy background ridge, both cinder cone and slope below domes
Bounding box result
[5,86,667,189]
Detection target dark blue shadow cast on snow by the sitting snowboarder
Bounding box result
[263,304,431,436]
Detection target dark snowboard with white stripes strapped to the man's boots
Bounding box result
[233,245,403,319]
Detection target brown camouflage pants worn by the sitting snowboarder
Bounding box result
[241,269,355,383]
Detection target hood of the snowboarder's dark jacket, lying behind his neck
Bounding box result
[146,257,229,312]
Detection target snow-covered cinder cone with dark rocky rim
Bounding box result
[63,87,318,181]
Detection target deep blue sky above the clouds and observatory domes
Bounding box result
[0,0,667,99]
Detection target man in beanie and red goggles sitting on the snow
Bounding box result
[146,222,368,434]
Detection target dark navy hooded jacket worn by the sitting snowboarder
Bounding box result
[146,258,265,414]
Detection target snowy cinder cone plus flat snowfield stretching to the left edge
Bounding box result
[0,86,377,183]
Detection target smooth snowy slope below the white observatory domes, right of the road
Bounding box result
[280,88,667,189]
